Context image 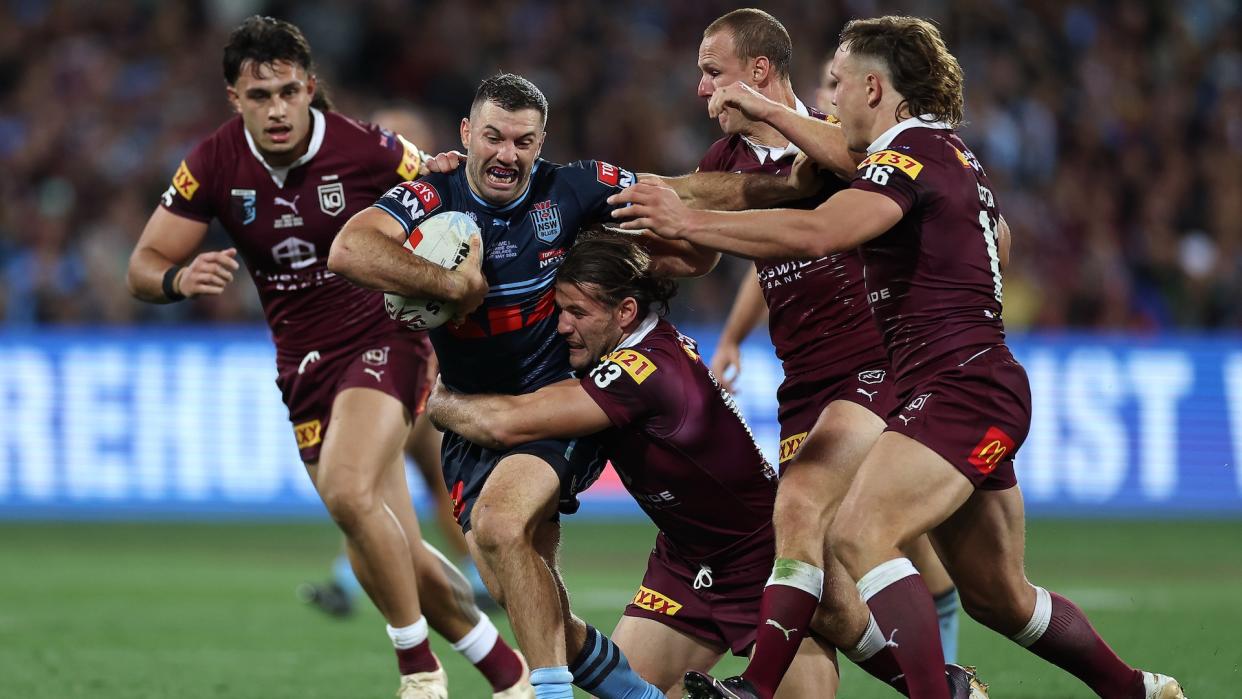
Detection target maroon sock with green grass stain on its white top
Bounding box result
[741,559,823,698]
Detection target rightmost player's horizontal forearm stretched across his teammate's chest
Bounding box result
[681,209,838,259]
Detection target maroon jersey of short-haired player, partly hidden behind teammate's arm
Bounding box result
[698,102,884,376]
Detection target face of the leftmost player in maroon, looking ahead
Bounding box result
[229,61,315,166]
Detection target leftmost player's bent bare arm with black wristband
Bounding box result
[125,206,240,303]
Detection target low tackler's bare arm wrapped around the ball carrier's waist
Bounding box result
[427,381,612,449]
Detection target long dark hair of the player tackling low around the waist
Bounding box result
[556,232,677,317]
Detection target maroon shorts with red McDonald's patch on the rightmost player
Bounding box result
[888,345,1031,490]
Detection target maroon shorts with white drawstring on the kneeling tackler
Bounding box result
[625,526,776,657]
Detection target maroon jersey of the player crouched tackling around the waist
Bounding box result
[582,314,776,562]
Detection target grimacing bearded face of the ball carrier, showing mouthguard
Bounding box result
[462,102,544,205]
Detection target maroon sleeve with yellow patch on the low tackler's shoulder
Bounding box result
[582,348,684,427]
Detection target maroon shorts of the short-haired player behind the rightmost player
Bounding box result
[776,360,897,467]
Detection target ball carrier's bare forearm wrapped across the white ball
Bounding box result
[328,223,466,302]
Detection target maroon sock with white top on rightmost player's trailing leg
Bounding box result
[1012,587,1145,699]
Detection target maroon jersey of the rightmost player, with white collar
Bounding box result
[850,119,1005,395]
